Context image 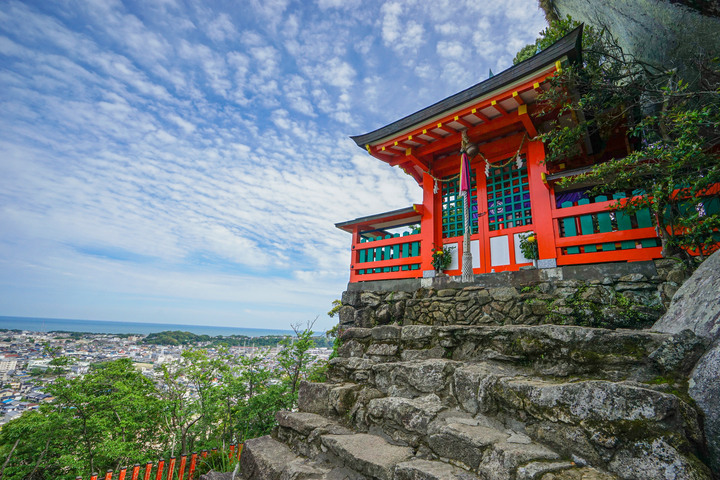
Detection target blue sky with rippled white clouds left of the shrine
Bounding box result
[0,0,545,329]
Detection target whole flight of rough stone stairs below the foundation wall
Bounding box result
[242,325,711,480]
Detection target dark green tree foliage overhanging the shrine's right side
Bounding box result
[518,18,720,258]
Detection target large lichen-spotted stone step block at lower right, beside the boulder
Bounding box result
[477,377,707,480]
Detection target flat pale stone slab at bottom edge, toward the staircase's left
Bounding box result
[320,433,415,480]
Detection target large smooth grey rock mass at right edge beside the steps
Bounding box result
[653,250,720,477]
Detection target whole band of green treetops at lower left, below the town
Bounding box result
[0,323,322,480]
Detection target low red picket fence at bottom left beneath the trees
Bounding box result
[76,443,243,480]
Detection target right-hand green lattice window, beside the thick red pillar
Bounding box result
[487,162,532,231]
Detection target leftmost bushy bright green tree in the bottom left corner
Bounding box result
[0,359,161,480]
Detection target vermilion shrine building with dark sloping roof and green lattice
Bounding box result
[336,27,720,282]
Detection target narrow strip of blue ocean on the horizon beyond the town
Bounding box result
[0,316,296,337]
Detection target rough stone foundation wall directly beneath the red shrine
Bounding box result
[339,259,691,329]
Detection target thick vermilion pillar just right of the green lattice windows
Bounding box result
[527,140,557,260]
